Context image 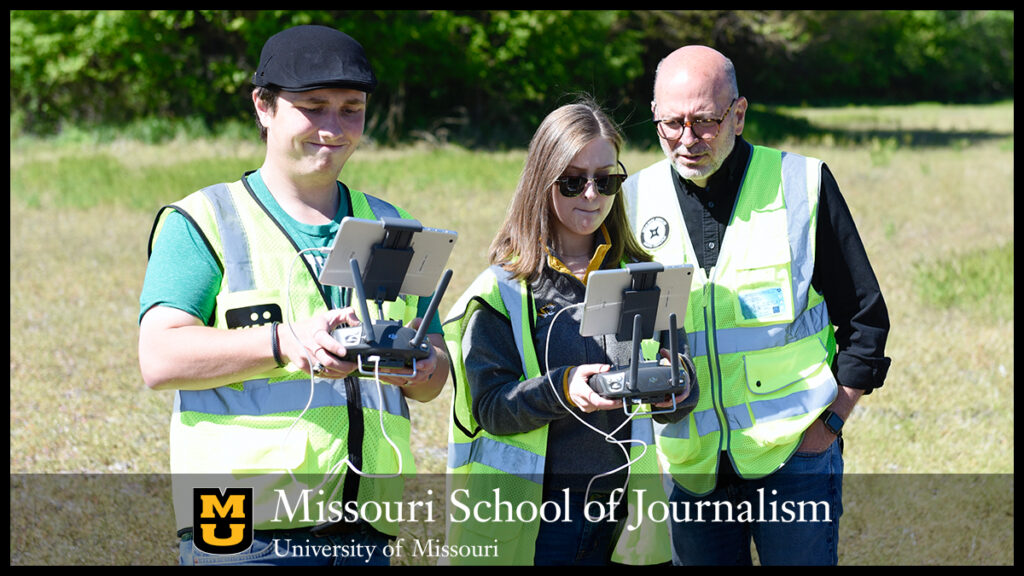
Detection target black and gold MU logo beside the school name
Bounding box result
[193,488,253,554]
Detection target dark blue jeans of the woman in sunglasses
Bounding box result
[534,492,621,566]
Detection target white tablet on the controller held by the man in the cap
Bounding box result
[319,216,458,297]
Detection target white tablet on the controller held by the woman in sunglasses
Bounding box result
[580,262,693,337]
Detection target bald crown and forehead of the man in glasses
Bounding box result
[654,46,739,104]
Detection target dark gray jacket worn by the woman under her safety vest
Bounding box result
[462,247,687,492]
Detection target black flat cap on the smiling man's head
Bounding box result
[253,25,377,94]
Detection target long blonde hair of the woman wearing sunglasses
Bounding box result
[489,98,651,282]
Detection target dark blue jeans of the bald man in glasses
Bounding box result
[670,441,843,566]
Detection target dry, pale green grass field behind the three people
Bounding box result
[10,102,1015,565]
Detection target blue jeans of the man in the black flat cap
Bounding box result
[178,530,391,566]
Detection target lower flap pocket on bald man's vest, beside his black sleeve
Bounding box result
[743,337,827,396]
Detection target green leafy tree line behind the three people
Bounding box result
[10,10,1014,146]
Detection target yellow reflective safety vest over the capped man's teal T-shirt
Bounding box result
[150,180,417,535]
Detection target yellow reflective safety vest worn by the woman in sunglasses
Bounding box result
[444,266,672,565]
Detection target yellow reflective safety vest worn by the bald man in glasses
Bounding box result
[625,147,838,495]
